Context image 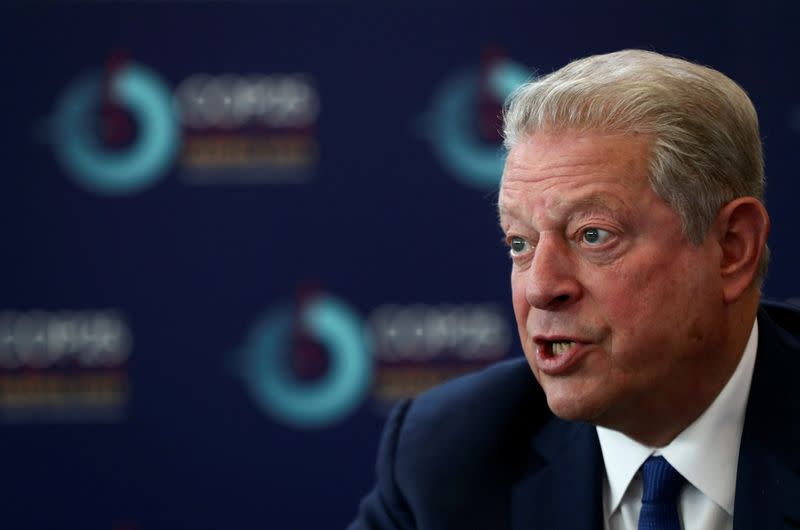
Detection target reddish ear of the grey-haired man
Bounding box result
[716,197,769,303]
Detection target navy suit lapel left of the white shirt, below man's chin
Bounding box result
[511,418,603,530]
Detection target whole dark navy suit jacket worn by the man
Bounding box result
[349,305,800,530]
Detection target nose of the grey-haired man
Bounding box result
[525,234,582,311]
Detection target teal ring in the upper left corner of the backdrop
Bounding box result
[52,64,180,195]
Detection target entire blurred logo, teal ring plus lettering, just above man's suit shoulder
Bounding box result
[235,290,511,428]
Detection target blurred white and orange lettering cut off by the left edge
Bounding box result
[0,310,132,423]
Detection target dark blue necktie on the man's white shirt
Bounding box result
[639,456,684,530]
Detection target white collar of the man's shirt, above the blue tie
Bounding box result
[597,321,758,515]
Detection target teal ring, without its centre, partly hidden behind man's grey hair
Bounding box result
[423,60,531,190]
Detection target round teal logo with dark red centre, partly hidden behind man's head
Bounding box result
[421,50,532,190]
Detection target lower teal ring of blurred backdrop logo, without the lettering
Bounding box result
[239,295,372,428]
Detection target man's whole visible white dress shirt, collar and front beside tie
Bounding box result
[597,322,758,530]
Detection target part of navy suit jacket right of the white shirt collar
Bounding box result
[733,309,800,530]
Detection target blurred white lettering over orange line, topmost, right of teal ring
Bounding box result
[175,74,319,184]
